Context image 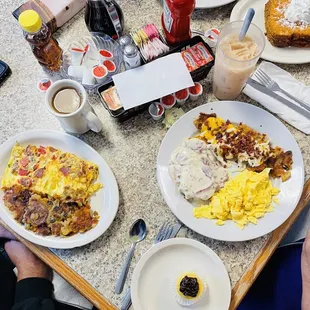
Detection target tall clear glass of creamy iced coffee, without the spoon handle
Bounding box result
[213,21,265,100]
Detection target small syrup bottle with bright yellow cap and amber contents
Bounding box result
[18,10,62,71]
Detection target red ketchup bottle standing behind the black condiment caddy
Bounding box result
[161,0,195,45]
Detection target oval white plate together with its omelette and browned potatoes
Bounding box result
[0,130,119,249]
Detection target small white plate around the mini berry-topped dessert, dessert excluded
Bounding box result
[131,238,231,310]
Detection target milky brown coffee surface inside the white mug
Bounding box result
[52,87,82,114]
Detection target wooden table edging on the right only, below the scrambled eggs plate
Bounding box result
[229,179,310,310]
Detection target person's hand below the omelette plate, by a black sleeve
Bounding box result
[4,240,53,281]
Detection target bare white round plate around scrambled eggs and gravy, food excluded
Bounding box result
[157,101,304,241]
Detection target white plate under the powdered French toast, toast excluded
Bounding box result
[230,0,310,64]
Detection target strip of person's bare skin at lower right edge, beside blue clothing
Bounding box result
[301,230,310,310]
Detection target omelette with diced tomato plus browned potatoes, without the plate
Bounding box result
[1,144,103,236]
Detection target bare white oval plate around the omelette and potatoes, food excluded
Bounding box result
[0,130,119,249]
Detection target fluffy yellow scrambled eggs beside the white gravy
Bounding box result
[193,169,280,229]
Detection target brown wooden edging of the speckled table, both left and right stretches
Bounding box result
[0,179,310,310]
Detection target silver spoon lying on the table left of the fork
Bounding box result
[115,219,146,294]
